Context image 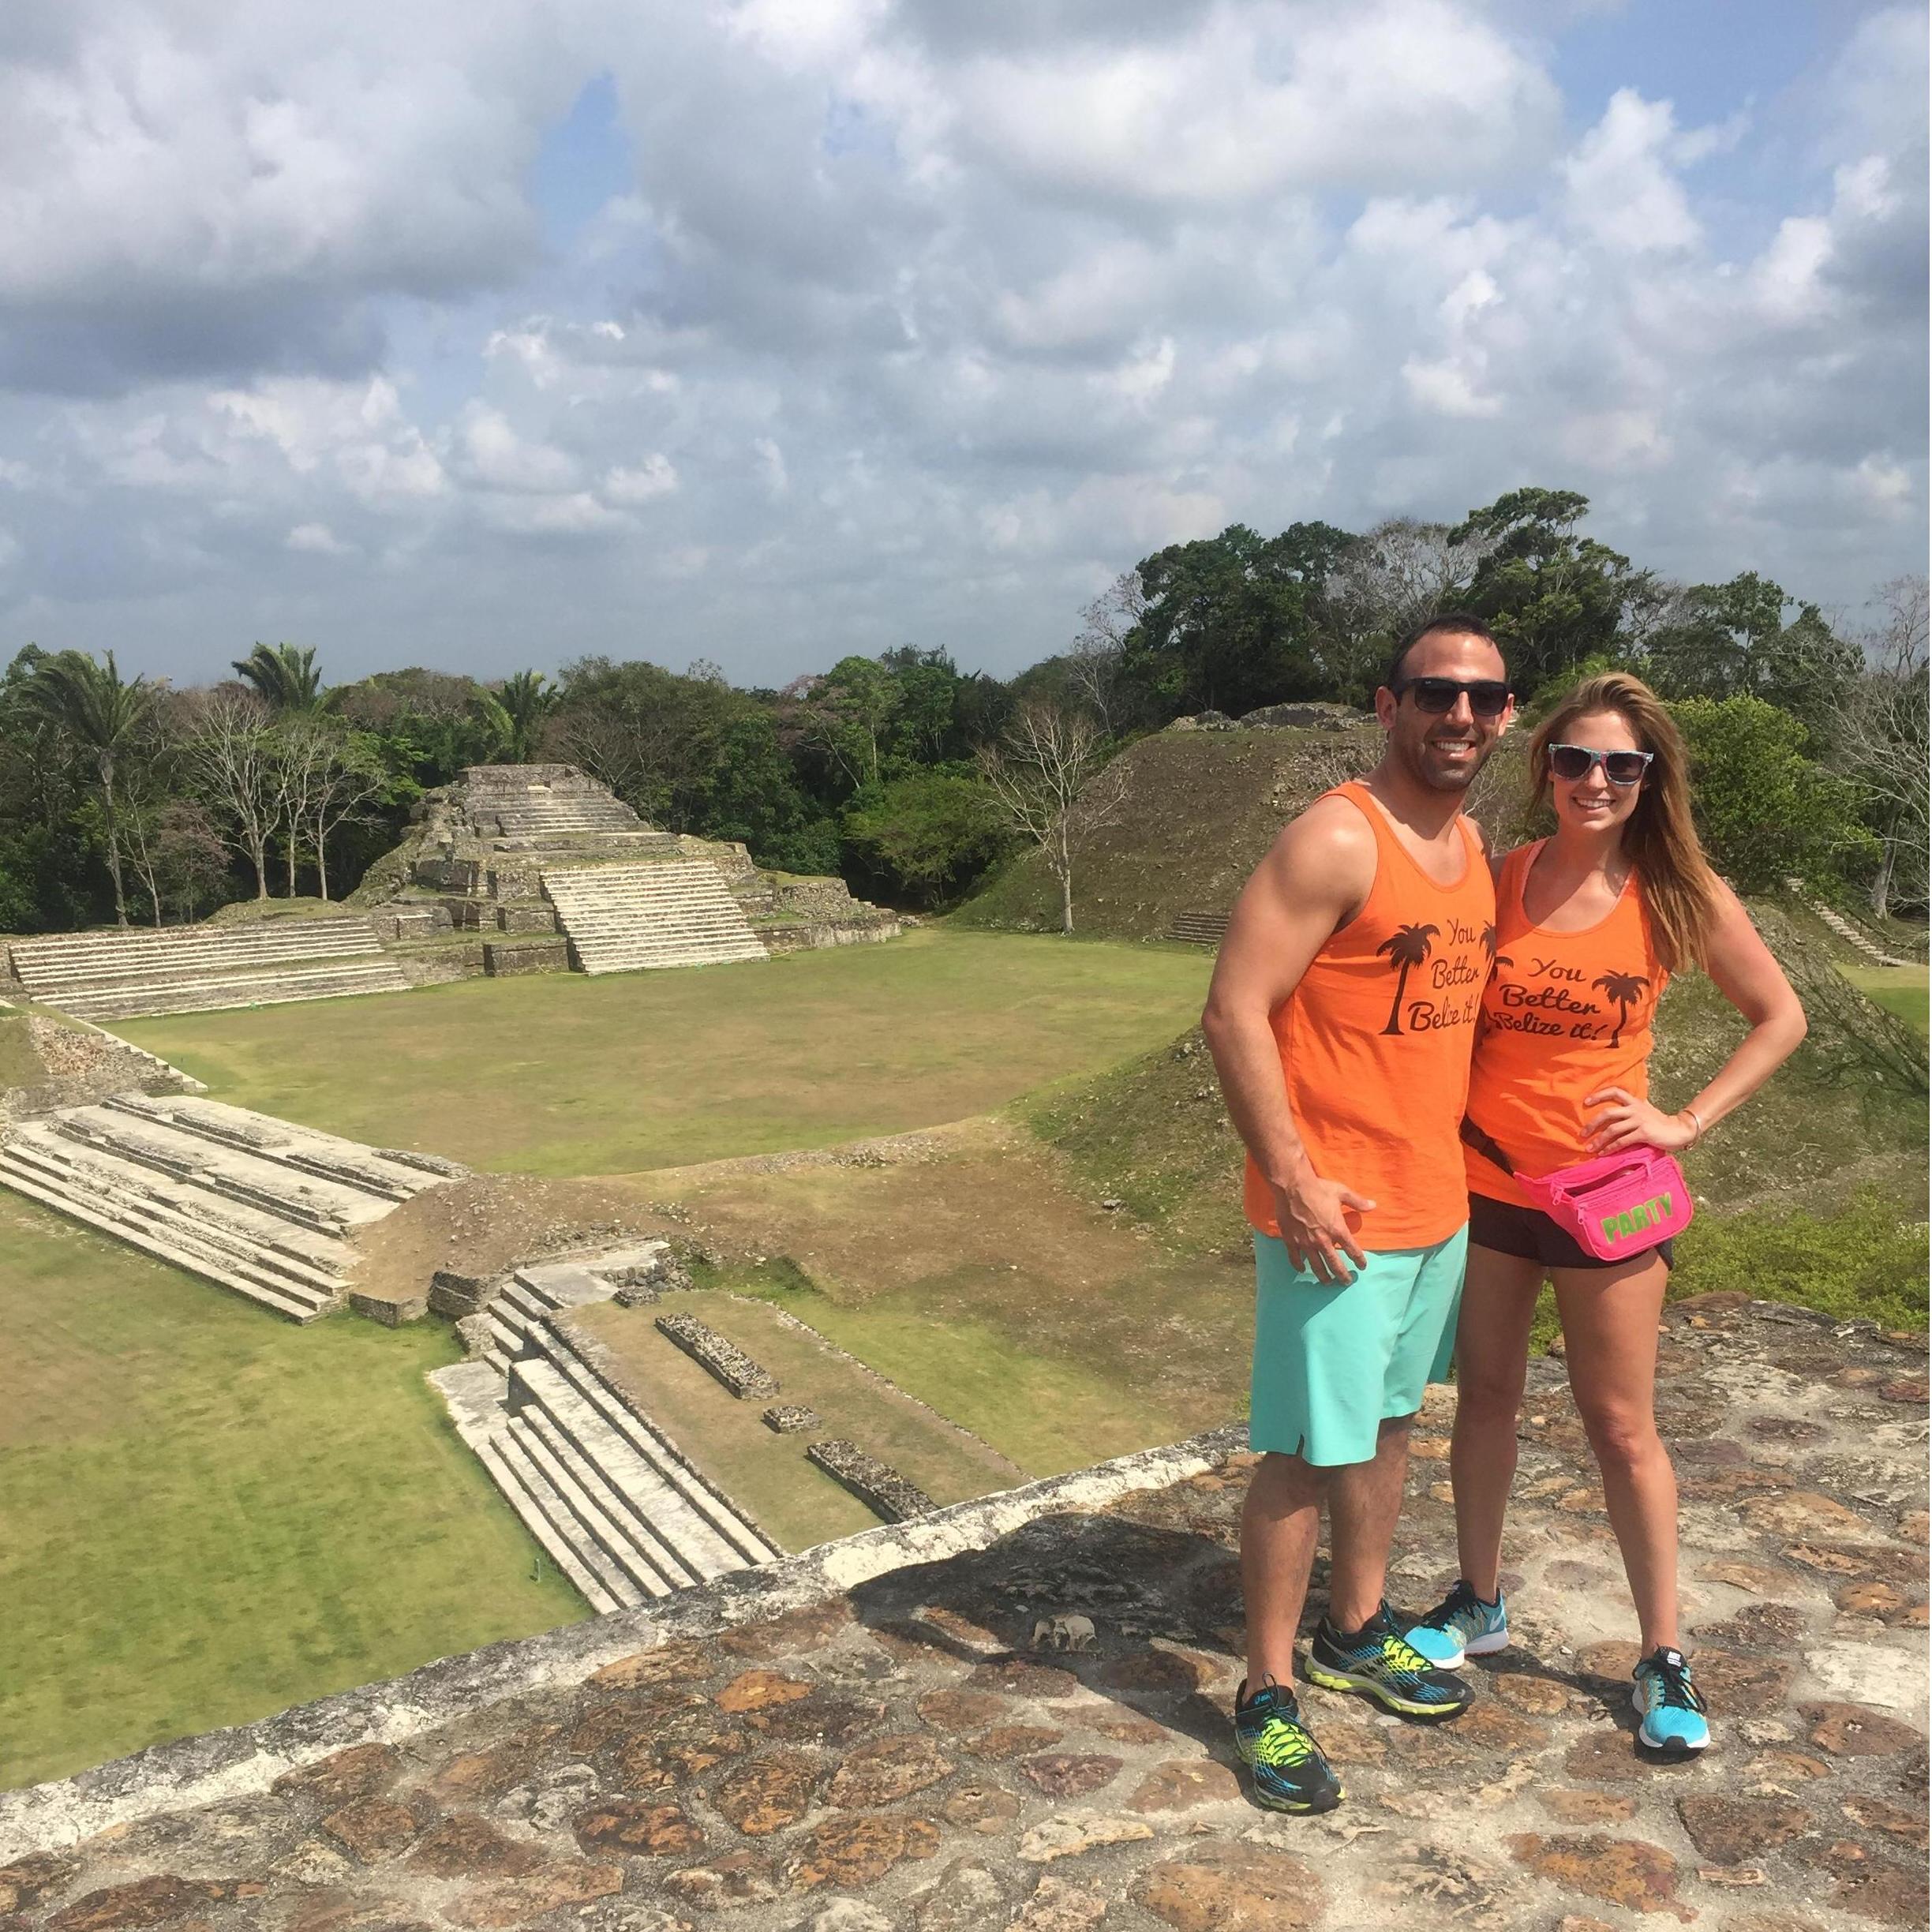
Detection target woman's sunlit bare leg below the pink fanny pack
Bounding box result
[1553,1252,1677,1656]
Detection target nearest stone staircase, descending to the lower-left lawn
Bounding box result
[429,1242,782,1613]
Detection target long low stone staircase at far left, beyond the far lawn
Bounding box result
[9,918,410,1020]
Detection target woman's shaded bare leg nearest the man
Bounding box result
[1449,1242,1544,1601]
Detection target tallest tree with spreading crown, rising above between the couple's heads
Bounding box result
[1449,489,1644,691]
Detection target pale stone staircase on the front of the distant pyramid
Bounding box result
[543,859,769,974]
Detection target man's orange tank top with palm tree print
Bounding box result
[1242,781,1496,1248]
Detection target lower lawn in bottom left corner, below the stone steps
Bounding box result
[0,1194,586,1787]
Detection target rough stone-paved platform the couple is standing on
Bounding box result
[0,1297,1926,1932]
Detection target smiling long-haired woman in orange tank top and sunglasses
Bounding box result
[1409,672,1804,1756]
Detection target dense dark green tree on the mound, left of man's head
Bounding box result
[1122,523,1353,719]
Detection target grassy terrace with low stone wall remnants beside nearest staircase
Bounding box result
[578,1290,1022,1549]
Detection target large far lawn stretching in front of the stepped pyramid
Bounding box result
[118,927,1209,1174]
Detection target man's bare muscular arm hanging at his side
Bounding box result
[1202,798,1376,1281]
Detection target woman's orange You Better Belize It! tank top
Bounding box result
[1465,841,1665,1208]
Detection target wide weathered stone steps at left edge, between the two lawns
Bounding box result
[0,1094,464,1321]
